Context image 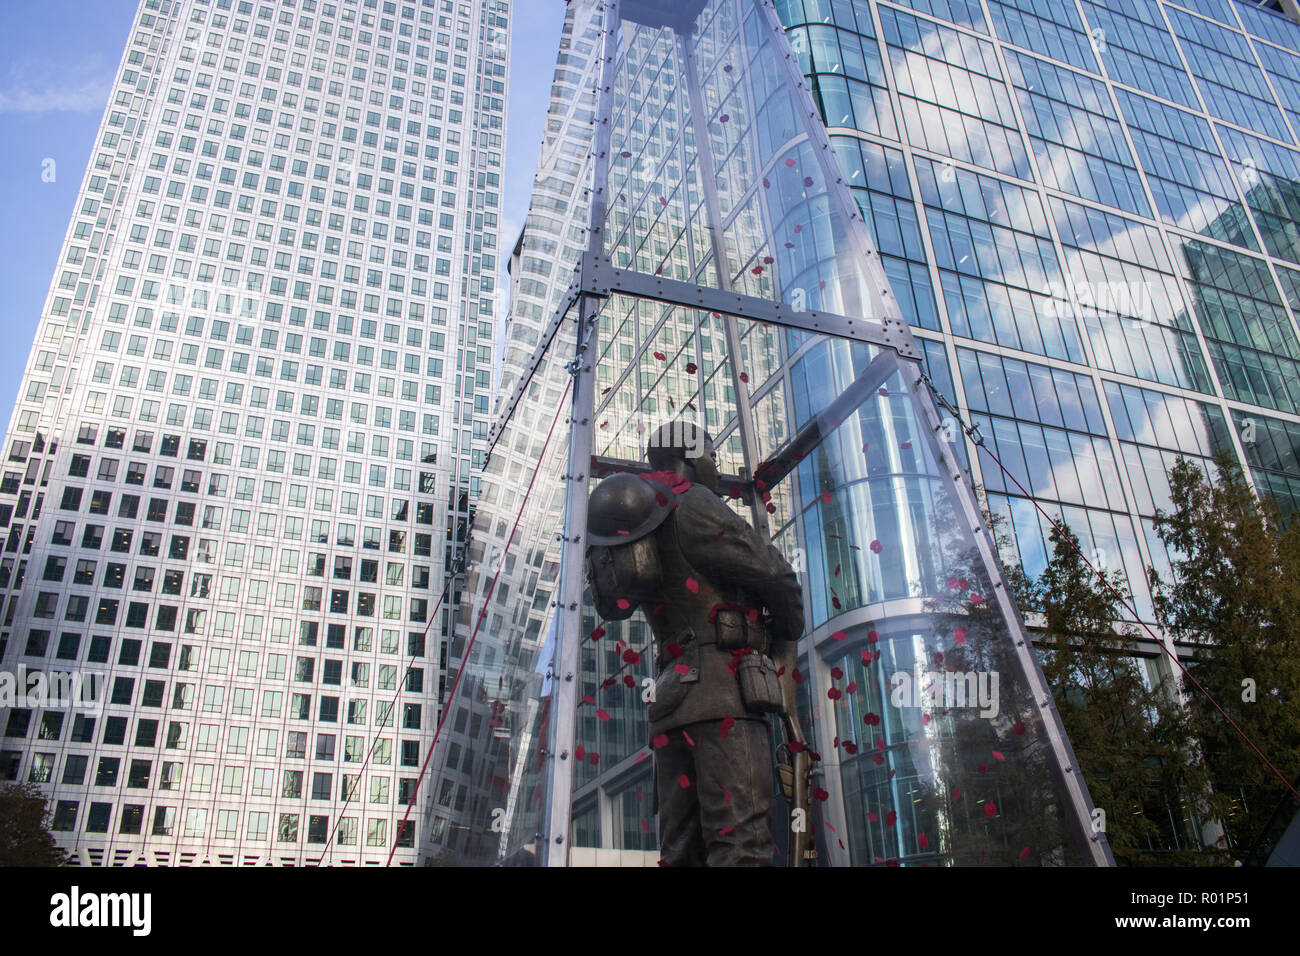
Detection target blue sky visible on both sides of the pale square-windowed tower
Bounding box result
[0,0,564,425]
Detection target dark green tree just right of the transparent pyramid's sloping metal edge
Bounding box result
[1009,524,1226,866]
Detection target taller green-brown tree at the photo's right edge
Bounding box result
[1151,453,1300,855]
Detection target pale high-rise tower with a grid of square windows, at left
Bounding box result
[0,0,510,865]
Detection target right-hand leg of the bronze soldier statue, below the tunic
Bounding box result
[690,719,774,866]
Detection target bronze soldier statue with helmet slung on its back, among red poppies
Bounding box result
[588,421,803,866]
